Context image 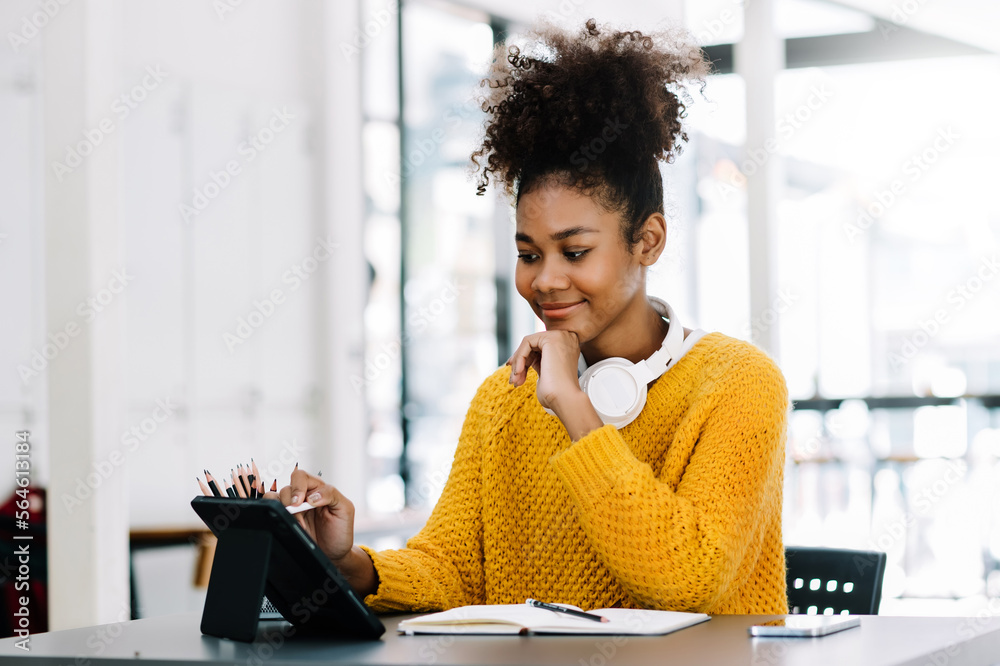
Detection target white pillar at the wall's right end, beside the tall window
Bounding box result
[304,0,372,514]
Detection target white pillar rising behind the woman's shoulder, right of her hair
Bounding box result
[734,0,785,360]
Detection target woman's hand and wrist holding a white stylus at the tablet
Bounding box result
[264,468,378,598]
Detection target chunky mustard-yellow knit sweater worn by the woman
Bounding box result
[365,333,789,614]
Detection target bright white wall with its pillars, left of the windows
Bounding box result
[0,0,367,628]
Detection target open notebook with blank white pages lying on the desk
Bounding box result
[398,604,709,636]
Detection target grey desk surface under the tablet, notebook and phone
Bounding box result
[0,612,1000,666]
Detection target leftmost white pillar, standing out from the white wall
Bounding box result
[41,0,129,630]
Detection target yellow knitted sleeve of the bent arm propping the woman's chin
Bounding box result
[550,352,788,612]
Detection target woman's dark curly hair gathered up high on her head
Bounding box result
[472,19,710,249]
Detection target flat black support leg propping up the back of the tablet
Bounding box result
[201,528,272,642]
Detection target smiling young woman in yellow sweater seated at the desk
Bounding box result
[279,21,788,613]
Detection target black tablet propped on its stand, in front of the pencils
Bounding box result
[191,497,385,640]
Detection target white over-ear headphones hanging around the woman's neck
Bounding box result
[543,296,684,428]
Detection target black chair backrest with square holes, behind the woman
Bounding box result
[785,546,885,615]
